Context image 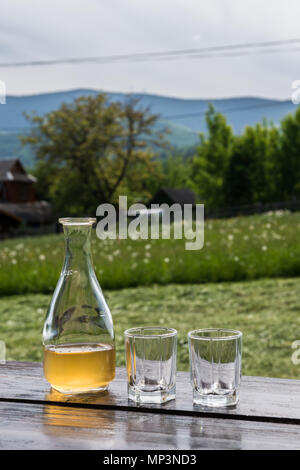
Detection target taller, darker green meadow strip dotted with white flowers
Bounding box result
[0,212,300,295]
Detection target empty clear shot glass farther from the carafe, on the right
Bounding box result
[188,329,243,407]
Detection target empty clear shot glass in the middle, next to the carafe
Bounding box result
[125,327,177,403]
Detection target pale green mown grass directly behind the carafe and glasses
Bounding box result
[0,278,300,378]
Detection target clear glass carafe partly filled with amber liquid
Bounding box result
[43,218,115,393]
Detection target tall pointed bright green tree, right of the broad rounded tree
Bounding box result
[193,105,233,207]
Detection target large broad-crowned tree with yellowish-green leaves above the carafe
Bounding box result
[22,94,164,215]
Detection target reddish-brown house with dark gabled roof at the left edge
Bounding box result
[0,159,53,232]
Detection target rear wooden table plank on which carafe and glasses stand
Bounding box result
[0,362,300,424]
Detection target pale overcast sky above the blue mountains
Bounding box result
[0,0,300,98]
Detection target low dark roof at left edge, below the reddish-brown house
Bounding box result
[0,201,53,224]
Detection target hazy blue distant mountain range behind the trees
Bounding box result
[0,89,296,165]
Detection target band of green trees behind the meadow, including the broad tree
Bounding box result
[22,94,300,215]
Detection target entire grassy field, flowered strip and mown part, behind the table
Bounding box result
[0,212,300,378]
